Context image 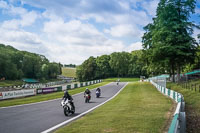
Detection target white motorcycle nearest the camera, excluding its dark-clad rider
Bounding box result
[61,99,75,116]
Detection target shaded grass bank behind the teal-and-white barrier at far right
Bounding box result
[167,80,200,133]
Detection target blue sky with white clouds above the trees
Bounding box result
[0,0,200,65]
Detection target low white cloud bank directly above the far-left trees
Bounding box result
[0,28,49,57]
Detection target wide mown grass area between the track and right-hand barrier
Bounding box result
[55,82,174,133]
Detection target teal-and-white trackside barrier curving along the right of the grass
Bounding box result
[150,80,186,133]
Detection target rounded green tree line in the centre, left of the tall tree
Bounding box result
[76,50,147,81]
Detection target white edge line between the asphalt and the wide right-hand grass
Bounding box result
[41,82,129,133]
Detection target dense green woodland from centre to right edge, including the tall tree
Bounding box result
[77,0,200,81]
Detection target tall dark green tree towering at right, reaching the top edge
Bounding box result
[142,0,197,81]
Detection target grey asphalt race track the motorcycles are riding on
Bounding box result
[0,82,126,133]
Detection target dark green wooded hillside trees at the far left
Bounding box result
[0,44,61,80]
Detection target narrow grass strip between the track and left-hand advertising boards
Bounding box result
[0,82,109,107]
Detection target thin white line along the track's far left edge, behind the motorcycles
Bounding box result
[0,82,113,109]
